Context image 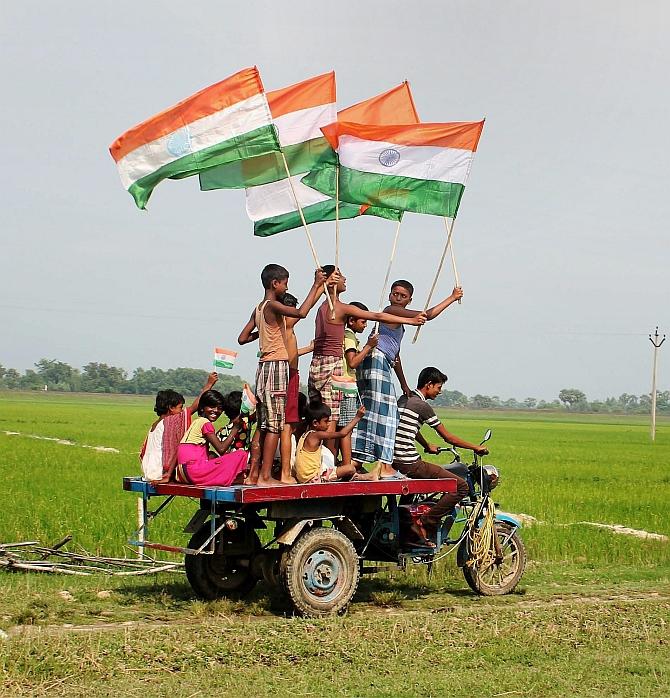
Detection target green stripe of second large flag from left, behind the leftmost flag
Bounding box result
[200,138,335,191]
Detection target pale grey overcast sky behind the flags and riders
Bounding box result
[0,0,670,400]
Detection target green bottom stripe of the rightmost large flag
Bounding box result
[301,166,465,218]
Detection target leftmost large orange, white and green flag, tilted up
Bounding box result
[109,67,279,209]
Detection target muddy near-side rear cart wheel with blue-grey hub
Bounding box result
[282,528,359,616]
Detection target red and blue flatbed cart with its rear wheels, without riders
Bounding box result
[123,468,525,616]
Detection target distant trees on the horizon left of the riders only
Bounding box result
[0,359,244,395]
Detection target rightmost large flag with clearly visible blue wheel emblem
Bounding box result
[303,121,484,218]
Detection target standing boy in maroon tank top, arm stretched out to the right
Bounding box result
[308,264,425,455]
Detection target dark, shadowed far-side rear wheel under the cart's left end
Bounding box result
[184,523,260,601]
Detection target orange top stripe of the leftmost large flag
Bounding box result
[109,67,263,162]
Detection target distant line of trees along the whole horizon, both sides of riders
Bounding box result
[0,359,670,414]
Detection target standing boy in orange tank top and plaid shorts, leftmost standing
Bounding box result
[237,264,326,486]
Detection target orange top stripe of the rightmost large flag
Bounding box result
[334,121,484,152]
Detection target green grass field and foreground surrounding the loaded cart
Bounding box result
[0,393,670,696]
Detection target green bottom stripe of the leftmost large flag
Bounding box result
[128,125,279,209]
